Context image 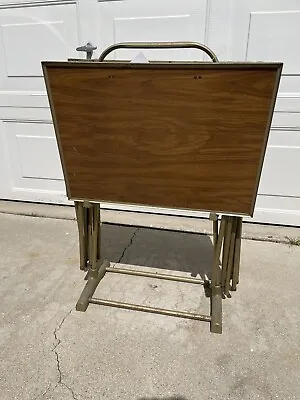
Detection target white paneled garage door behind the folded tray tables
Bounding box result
[0,0,300,225]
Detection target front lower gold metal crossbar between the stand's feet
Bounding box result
[90,297,211,322]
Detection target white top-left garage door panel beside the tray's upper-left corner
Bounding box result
[0,1,78,94]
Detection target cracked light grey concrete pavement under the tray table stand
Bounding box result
[0,214,300,400]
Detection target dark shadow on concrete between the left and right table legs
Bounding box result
[102,224,213,279]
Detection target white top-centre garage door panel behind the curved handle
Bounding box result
[98,0,207,60]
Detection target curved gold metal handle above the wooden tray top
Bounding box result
[99,42,219,62]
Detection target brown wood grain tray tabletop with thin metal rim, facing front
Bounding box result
[43,62,281,215]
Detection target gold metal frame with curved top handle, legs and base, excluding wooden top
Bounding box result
[70,42,246,333]
